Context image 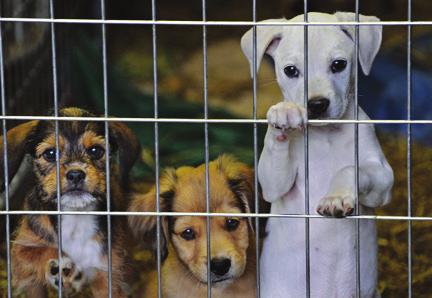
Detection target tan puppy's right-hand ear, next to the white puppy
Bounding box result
[216,155,255,231]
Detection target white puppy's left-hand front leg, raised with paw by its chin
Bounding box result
[258,102,306,202]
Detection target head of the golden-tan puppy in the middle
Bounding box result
[130,156,253,286]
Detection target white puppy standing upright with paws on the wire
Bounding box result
[241,12,393,298]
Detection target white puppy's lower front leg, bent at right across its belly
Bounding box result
[317,160,393,217]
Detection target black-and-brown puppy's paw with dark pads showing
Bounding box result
[45,256,85,293]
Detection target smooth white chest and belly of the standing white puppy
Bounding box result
[260,121,376,298]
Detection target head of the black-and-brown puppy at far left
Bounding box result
[1,108,139,210]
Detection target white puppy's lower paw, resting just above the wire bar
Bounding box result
[316,195,355,217]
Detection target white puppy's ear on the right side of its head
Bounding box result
[334,11,382,75]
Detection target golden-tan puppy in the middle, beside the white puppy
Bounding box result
[129,156,256,298]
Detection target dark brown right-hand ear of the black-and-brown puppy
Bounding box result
[109,122,141,187]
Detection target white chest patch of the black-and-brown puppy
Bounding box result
[61,215,106,277]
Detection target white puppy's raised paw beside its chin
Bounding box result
[267,101,307,141]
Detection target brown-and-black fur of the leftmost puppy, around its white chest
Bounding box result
[0,108,140,297]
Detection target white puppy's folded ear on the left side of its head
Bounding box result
[241,19,286,77]
